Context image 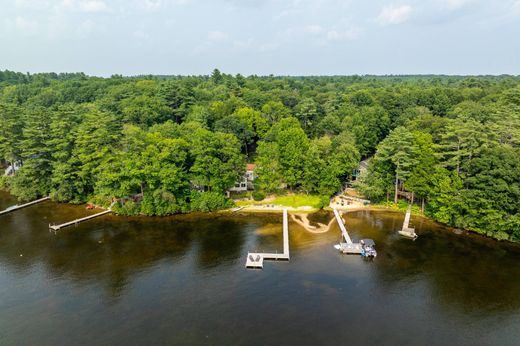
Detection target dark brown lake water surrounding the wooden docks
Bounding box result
[0,192,520,345]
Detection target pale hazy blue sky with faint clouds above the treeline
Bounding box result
[0,0,520,76]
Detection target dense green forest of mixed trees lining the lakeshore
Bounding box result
[0,70,520,241]
